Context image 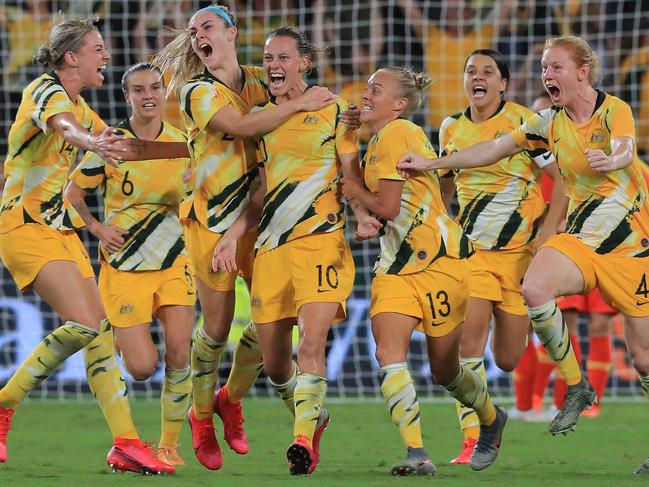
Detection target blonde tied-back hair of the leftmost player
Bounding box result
[32,13,99,68]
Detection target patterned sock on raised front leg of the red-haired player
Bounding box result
[528,300,582,386]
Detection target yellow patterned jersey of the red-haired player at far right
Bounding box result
[512,91,649,257]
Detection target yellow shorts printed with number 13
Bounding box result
[370,257,471,337]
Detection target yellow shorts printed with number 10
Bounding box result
[250,230,355,324]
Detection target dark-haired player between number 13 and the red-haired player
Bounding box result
[440,49,566,464]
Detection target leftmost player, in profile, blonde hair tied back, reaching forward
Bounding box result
[0,19,174,473]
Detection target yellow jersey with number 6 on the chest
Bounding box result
[70,120,189,271]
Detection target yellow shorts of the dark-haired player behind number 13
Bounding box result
[469,245,532,316]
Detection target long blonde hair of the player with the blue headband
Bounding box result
[151,4,235,93]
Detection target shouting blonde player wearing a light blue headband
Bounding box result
[154,6,342,470]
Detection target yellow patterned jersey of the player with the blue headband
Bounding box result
[179,66,268,233]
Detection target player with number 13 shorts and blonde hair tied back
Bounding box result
[342,67,507,475]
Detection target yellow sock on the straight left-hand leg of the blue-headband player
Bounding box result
[192,328,225,419]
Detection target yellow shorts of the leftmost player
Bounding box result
[0,223,95,291]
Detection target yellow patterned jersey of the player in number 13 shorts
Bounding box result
[363,119,473,274]
